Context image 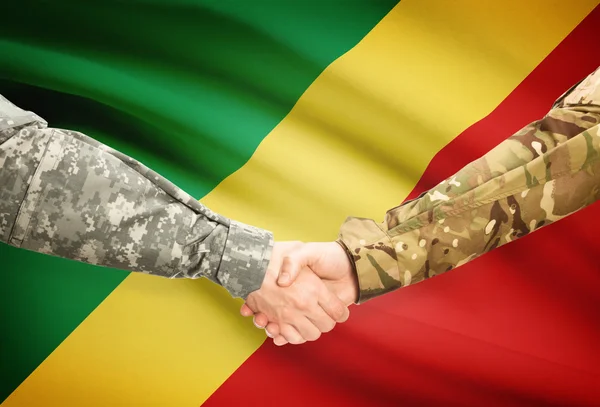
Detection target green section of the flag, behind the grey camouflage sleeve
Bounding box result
[0,0,397,400]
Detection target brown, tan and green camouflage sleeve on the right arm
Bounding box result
[339,69,600,302]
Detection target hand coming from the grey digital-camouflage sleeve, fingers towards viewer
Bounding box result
[244,242,348,344]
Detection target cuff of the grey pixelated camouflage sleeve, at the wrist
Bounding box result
[217,221,273,299]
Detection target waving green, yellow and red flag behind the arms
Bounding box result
[0,0,600,407]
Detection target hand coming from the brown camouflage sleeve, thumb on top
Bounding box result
[241,242,358,345]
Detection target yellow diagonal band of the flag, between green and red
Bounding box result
[4,0,598,407]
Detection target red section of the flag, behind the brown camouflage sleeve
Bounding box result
[204,7,600,407]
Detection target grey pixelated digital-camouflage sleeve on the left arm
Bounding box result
[0,96,273,298]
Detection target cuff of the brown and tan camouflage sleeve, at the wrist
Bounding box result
[338,218,402,304]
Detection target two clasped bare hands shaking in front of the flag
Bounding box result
[241,242,358,346]
